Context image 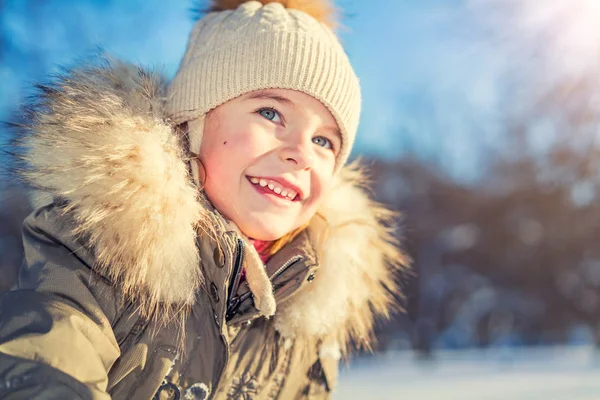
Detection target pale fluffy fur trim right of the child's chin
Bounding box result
[275,162,409,355]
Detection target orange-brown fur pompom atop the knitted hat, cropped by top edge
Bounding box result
[210,0,337,29]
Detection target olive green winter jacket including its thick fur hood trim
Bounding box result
[0,63,405,400]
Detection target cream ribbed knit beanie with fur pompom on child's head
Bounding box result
[166,0,361,169]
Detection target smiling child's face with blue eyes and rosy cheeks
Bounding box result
[195,89,341,240]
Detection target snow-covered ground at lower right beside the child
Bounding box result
[333,347,600,400]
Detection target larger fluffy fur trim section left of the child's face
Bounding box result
[12,60,203,314]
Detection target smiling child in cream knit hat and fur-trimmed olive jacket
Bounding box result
[0,0,406,400]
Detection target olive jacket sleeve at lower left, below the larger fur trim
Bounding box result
[0,205,120,400]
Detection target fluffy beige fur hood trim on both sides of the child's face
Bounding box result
[11,58,407,352]
